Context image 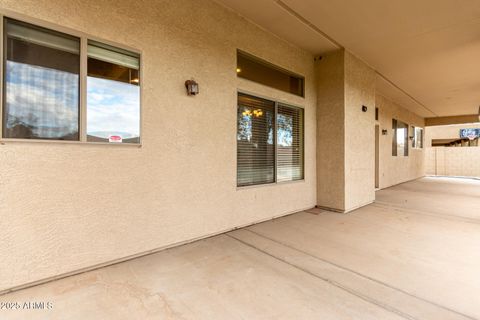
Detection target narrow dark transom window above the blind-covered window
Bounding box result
[237,51,305,97]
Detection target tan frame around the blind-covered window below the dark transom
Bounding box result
[235,89,306,190]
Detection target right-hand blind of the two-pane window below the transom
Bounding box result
[277,104,304,182]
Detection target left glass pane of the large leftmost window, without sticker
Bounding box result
[3,19,80,140]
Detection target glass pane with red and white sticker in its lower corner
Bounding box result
[87,41,140,143]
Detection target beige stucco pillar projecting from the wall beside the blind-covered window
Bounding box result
[316,50,375,211]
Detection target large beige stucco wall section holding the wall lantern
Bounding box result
[0,0,316,291]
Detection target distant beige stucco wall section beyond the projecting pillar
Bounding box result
[376,94,425,188]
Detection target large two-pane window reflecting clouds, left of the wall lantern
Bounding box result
[1,18,140,143]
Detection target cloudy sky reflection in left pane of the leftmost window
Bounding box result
[5,61,79,140]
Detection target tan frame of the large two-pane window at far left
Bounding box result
[0,9,143,147]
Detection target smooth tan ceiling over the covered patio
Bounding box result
[217,0,480,117]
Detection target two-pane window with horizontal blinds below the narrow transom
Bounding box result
[237,93,304,187]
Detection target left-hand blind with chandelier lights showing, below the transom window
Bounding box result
[237,94,275,186]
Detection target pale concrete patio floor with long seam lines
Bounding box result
[0,178,480,320]
